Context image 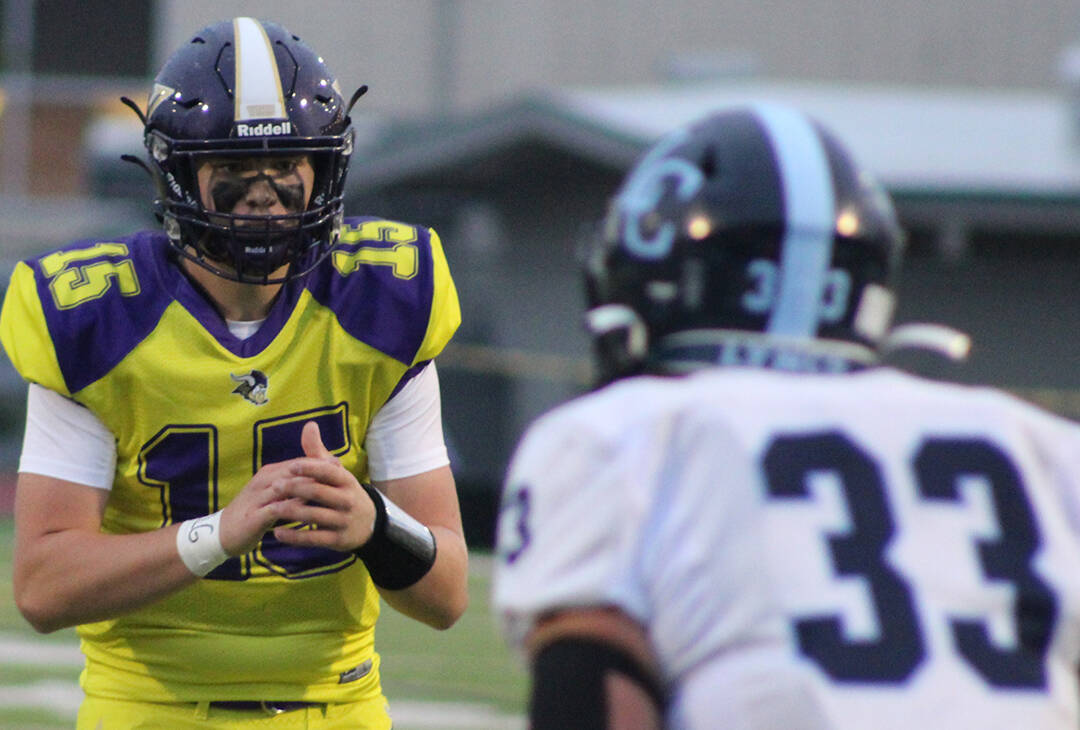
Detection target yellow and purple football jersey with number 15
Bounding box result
[0,218,460,702]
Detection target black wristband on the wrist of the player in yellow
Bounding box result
[356,484,436,591]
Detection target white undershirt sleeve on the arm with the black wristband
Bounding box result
[364,362,450,482]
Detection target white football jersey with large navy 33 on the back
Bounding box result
[494,368,1080,730]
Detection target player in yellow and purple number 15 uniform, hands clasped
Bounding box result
[0,18,468,730]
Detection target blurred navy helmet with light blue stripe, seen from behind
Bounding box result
[584,105,905,382]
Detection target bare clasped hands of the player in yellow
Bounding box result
[213,421,375,555]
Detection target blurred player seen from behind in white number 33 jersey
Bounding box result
[495,106,1080,730]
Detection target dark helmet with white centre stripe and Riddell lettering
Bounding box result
[137,17,358,284]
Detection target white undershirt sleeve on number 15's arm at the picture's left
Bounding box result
[18,383,117,489]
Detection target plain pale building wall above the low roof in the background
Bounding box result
[158,0,1080,113]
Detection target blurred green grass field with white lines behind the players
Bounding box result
[0,517,526,730]
